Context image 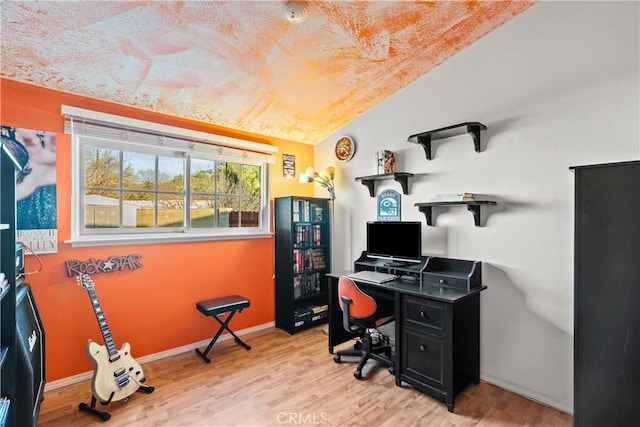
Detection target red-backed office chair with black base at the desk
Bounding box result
[333,277,394,379]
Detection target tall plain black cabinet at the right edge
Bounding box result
[571,161,640,427]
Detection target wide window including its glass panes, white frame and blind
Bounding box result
[63,106,277,246]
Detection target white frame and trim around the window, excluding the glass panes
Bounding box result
[62,105,278,247]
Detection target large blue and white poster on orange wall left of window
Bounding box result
[2,126,58,254]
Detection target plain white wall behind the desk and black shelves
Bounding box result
[316,2,640,413]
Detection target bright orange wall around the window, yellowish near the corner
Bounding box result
[0,79,313,382]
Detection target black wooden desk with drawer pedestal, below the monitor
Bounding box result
[327,271,486,412]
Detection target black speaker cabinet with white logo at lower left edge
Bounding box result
[11,284,45,427]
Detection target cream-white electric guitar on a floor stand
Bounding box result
[78,273,152,405]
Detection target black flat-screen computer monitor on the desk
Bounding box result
[367,221,422,266]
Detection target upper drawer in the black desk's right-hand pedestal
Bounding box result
[402,296,449,336]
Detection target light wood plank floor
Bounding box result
[38,327,573,427]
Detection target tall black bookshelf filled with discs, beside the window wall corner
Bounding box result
[274,196,331,334]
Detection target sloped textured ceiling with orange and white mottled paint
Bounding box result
[1,1,535,144]
